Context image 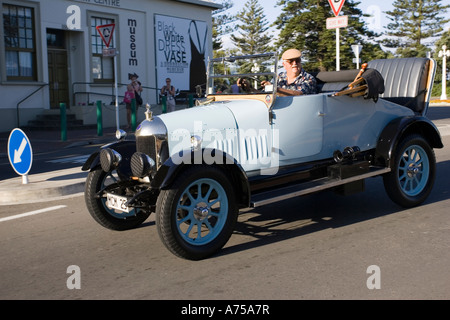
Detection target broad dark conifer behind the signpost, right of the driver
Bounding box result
[274,0,387,71]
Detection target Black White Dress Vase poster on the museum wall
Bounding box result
[155,15,211,92]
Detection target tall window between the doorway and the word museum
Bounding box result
[91,16,114,83]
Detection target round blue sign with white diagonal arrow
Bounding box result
[8,128,33,175]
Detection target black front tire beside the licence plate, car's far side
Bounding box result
[84,169,150,231]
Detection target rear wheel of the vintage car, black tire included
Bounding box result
[383,134,436,208]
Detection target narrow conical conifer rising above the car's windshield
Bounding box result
[231,0,271,55]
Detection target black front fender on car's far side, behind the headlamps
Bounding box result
[81,140,136,177]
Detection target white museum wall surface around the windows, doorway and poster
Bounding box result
[0,0,212,131]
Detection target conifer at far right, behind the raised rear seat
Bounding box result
[383,0,450,57]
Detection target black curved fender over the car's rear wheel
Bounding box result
[375,116,444,167]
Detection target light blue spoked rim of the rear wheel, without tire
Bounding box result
[398,145,430,197]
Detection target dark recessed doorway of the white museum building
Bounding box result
[47,29,70,109]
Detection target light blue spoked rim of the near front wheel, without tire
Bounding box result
[175,179,228,246]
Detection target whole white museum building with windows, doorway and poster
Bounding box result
[0,0,220,131]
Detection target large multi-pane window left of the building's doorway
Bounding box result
[3,4,36,81]
